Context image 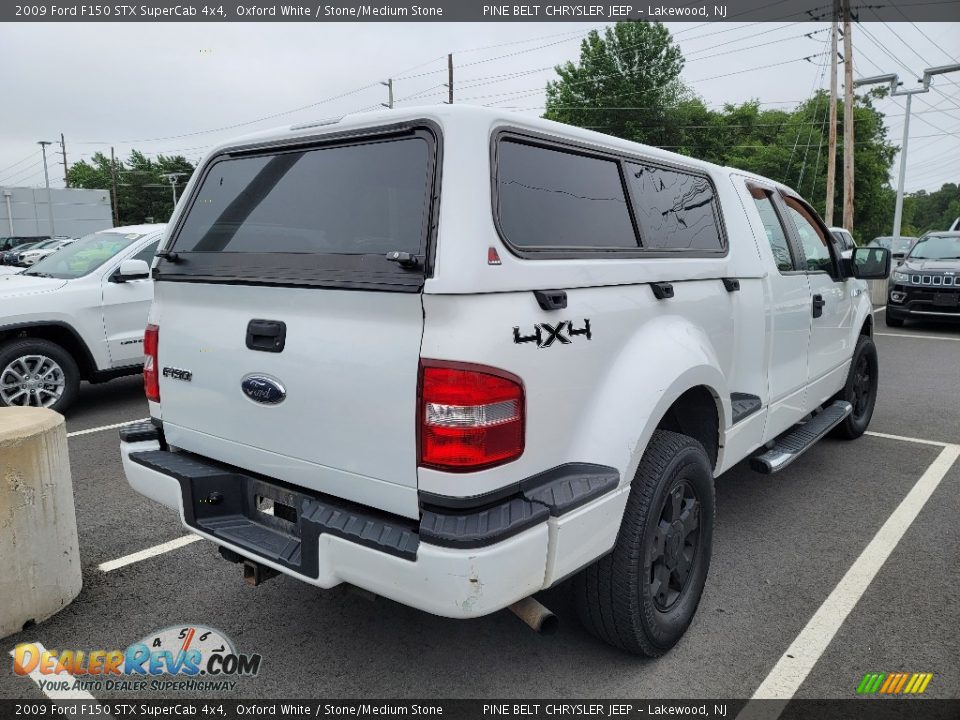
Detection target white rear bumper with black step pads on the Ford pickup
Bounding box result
[121,424,629,618]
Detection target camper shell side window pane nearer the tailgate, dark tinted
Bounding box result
[497,139,637,250]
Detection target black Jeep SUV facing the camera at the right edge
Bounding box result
[887,231,960,327]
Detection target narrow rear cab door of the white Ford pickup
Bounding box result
[747,183,812,441]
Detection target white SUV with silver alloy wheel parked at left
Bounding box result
[0,225,164,412]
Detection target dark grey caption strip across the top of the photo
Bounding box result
[0,0,960,23]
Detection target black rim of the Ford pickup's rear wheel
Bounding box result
[648,480,700,612]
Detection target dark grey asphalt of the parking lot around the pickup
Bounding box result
[0,311,960,700]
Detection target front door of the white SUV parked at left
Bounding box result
[102,238,160,367]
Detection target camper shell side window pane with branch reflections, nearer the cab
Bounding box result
[625,163,723,251]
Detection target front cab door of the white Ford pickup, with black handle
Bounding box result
[782,195,862,412]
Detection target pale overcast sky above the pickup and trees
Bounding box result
[0,22,960,198]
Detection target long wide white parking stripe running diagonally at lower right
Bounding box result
[752,445,960,704]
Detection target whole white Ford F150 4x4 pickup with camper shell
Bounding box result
[121,106,889,656]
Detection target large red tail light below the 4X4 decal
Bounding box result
[417,360,524,472]
